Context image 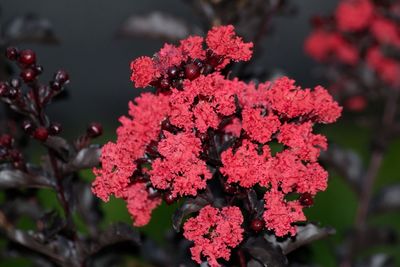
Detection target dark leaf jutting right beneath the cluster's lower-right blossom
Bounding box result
[266,223,336,255]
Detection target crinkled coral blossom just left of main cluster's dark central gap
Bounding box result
[149,132,212,197]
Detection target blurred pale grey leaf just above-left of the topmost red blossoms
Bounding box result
[118,11,197,41]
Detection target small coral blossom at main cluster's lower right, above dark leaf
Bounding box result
[264,189,306,236]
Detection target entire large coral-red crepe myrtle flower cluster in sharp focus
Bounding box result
[92,26,342,266]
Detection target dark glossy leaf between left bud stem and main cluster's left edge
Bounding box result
[64,146,101,172]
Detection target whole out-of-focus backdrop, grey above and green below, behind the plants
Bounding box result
[0,0,400,266]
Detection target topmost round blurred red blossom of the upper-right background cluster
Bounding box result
[335,0,374,31]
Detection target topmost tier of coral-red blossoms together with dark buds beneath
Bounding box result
[131,25,253,89]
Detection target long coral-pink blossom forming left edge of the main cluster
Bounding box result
[92,93,169,224]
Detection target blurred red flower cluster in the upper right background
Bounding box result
[305,0,400,87]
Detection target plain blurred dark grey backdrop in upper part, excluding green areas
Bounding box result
[0,0,337,134]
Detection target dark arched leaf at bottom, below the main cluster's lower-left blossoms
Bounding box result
[89,223,141,255]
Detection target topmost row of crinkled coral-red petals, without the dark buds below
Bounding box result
[131,25,253,87]
